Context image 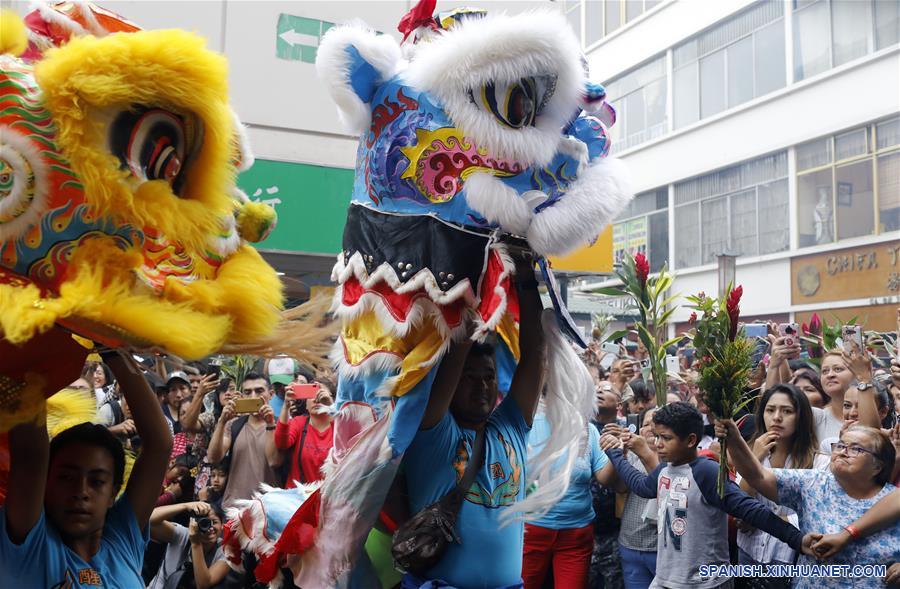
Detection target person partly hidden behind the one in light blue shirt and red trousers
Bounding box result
[588,382,630,589]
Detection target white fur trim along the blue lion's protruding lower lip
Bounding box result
[527,158,634,256]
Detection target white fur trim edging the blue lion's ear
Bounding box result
[316,22,405,134]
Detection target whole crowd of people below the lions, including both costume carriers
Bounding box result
[0,306,900,589]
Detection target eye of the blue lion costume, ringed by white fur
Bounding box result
[469,77,554,129]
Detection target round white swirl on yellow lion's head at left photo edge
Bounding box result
[0,125,50,242]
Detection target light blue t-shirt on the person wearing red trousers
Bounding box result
[528,414,609,530]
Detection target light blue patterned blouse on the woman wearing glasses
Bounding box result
[772,468,900,589]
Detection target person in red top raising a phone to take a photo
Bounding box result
[269,383,334,489]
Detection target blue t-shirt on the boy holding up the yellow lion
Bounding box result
[0,495,150,589]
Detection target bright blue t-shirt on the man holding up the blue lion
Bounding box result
[403,396,530,588]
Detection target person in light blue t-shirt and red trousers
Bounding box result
[522,413,614,589]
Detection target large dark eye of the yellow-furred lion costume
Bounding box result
[110,107,199,196]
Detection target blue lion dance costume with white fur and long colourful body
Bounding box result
[219,1,631,587]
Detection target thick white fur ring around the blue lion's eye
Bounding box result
[404,10,585,166]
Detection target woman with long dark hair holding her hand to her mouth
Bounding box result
[737,384,828,589]
